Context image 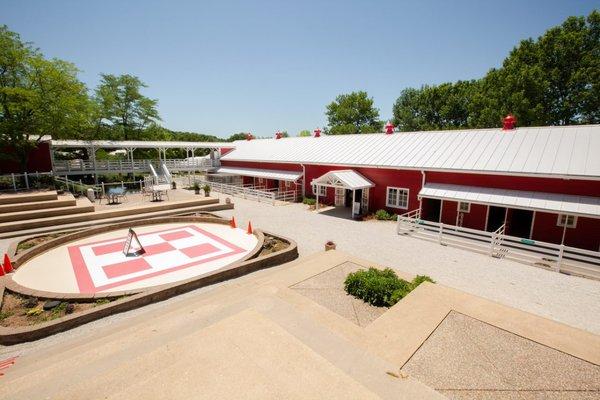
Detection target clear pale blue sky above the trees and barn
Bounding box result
[0,0,598,136]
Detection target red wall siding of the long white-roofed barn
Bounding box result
[223,161,600,251]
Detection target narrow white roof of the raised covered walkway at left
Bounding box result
[52,140,235,149]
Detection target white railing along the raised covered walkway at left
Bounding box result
[52,159,220,173]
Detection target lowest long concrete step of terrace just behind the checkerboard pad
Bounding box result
[0,199,233,239]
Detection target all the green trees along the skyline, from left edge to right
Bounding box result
[0,11,600,166]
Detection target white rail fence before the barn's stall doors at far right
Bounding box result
[397,210,600,279]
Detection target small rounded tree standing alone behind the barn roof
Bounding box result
[325,91,383,135]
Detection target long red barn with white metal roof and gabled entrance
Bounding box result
[217,125,600,251]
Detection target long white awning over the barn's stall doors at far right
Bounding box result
[419,183,600,218]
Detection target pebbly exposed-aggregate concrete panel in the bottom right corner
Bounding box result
[403,312,600,399]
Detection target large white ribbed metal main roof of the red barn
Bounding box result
[222,125,600,178]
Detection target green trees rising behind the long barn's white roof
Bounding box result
[326,11,600,134]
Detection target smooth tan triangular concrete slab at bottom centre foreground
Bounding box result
[61,310,378,399]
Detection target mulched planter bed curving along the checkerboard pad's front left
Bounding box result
[0,290,117,327]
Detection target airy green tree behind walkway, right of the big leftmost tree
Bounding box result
[96,74,160,140]
